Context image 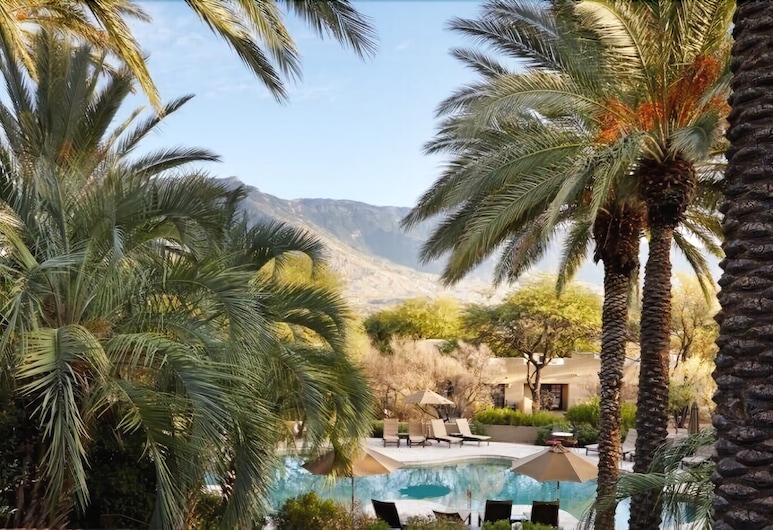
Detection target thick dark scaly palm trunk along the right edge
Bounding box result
[712,0,773,530]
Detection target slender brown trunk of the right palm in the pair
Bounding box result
[629,224,674,530]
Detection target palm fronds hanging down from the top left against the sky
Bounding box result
[0,0,376,110]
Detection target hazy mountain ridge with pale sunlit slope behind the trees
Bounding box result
[220,177,498,311]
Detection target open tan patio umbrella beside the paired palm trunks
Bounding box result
[510,444,599,498]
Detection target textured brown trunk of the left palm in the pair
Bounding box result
[594,268,631,530]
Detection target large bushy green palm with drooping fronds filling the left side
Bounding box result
[0,32,371,527]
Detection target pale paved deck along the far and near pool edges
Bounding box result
[363,438,633,530]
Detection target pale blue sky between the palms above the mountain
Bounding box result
[136,1,478,206]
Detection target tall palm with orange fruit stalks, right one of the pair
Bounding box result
[581,5,733,529]
